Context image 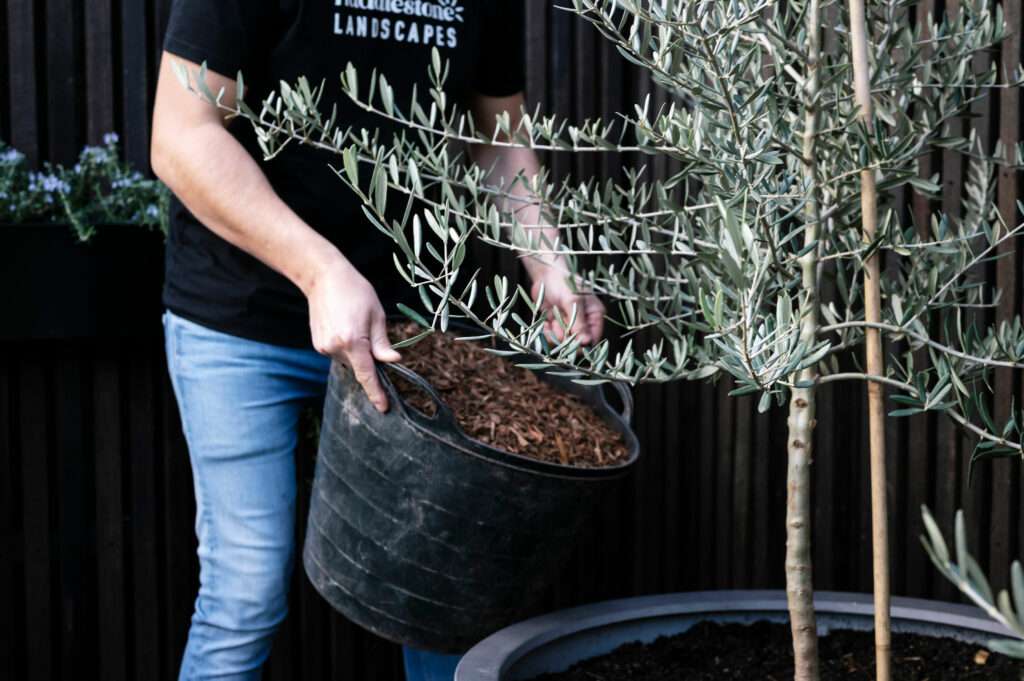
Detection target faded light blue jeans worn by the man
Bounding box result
[164,312,458,681]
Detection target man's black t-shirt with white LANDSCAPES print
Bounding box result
[164,0,524,347]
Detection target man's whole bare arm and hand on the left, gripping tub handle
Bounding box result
[151,52,399,411]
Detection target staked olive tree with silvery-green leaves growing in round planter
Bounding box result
[182,0,1024,681]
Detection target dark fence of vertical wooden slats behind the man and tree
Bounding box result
[0,0,1024,681]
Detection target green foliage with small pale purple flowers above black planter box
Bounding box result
[0,132,171,242]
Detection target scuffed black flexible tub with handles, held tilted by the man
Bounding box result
[303,348,639,652]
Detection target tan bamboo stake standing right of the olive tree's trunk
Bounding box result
[850,0,892,681]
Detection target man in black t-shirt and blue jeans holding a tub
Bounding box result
[152,0,603,681]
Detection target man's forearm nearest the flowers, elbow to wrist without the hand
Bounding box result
[153,122,347,293]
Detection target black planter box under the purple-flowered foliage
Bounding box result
[0,224,164,341]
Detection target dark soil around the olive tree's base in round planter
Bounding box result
[534,622,1024,681]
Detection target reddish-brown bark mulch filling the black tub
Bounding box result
[390,323,629,468]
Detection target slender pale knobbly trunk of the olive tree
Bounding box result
[785,0,821,681]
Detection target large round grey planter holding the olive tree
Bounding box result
[455,591,1010,681]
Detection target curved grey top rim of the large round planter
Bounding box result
[457,591,1013,680]
